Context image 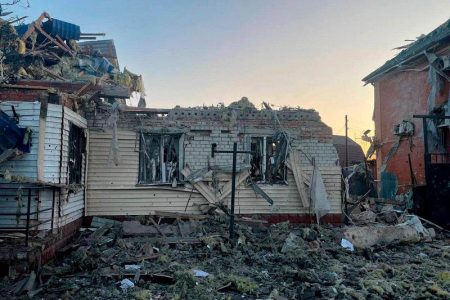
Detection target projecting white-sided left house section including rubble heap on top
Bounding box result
[0,13,143,255]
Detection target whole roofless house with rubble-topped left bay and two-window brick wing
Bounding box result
[0,13,342,268]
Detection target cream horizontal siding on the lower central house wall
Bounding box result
[87,130,341,216]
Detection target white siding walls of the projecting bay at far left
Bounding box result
[0,101,86,229]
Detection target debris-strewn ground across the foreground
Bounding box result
[1,217,450,299]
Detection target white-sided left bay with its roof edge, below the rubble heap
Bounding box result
[0,80,130,246]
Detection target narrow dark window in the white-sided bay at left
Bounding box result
[69,123,86,184]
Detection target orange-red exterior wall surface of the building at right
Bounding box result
[374,71,448,193]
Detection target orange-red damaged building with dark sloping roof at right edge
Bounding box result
[363,21,450,225]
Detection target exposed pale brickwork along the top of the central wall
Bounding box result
[86,106,338,169]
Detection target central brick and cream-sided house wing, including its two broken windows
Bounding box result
[86,102,341,222]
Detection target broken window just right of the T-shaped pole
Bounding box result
[250,136,287,183]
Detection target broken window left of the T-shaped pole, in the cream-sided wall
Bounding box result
[139,133,180,184]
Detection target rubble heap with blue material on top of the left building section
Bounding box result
[0,12,144,94]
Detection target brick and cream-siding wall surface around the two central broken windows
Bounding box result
[86,105,341,216]
